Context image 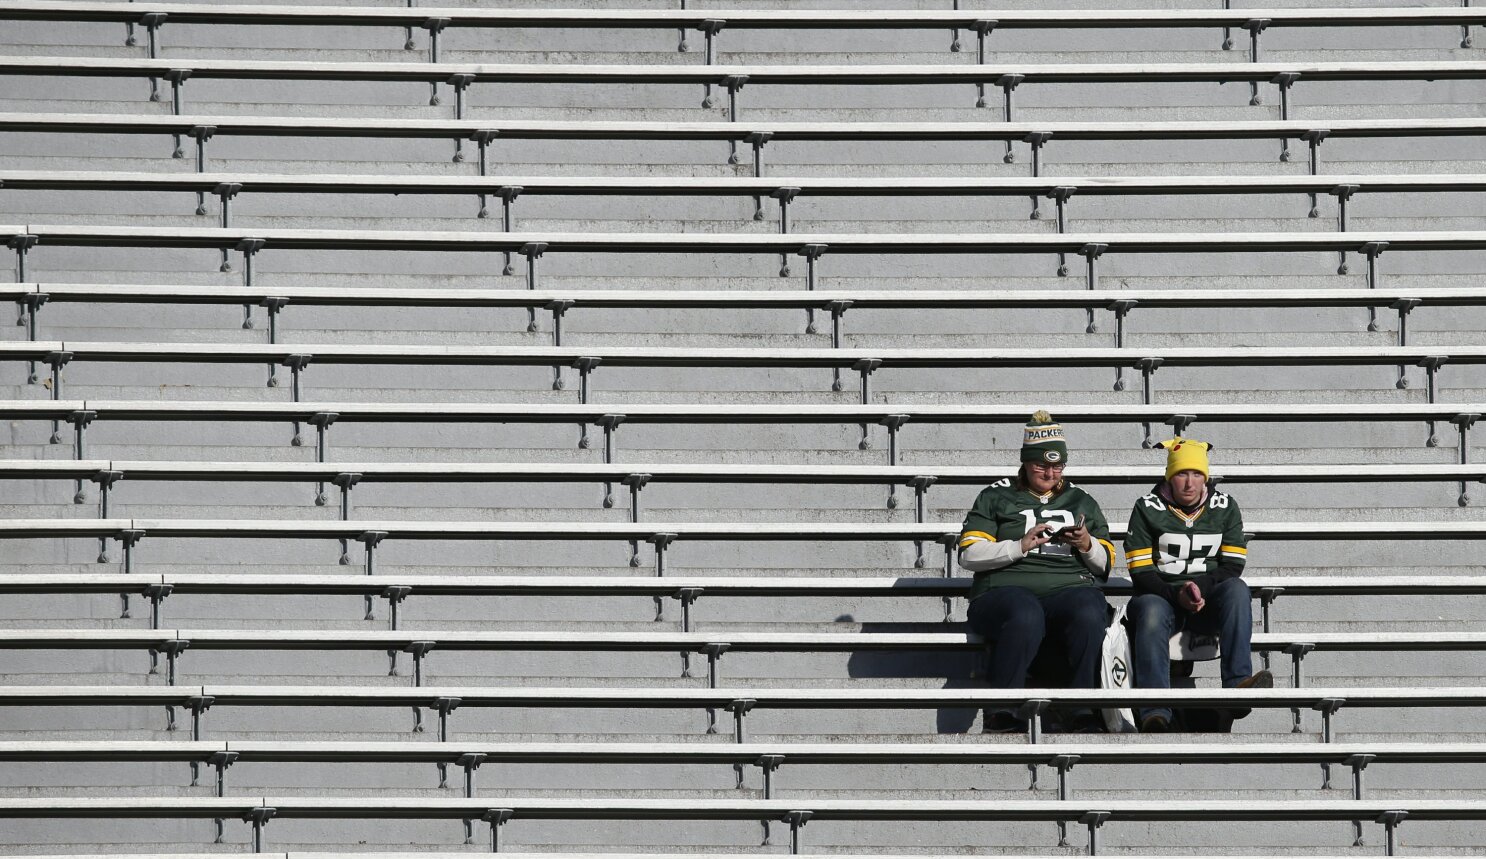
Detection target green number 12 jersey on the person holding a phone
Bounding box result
[960,477,1115,599]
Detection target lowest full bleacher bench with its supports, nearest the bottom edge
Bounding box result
[0,797,1486,855]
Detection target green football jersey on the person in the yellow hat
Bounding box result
[1125,489,1248,584]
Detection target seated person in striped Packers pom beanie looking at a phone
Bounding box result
[960,412,1115,733]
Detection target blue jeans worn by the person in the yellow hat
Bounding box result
[1126,578,1254,719]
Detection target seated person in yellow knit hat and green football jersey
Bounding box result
[1125,438,1275,733]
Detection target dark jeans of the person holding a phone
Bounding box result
[969,587,1109,690]
